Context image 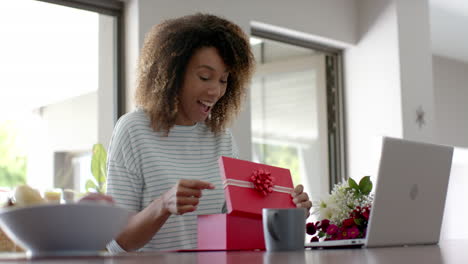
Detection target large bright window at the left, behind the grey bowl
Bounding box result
[0,0,123,196]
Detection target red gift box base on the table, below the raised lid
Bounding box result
[198,214,265,250]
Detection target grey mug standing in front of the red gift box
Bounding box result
[262,208,306,251]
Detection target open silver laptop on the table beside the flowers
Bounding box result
[305,137,453,248]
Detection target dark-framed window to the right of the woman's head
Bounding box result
[250,28,345,200]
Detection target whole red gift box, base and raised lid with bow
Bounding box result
[198,157,296,250]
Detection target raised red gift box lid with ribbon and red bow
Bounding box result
[218,156,296,217]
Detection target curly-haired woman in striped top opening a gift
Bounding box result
[107,14,312,251]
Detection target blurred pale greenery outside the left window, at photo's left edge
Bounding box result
[0,121,27,188]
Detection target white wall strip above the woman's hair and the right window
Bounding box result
[135,0,356,51]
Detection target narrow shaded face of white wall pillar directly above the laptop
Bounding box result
[395,0,436,142]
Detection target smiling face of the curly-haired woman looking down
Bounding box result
[176,47,229,126]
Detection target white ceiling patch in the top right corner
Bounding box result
[429,0,468,62]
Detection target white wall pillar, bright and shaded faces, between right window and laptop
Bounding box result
[345,0,435,180]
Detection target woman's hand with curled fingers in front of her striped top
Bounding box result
[162,180,215,214]
